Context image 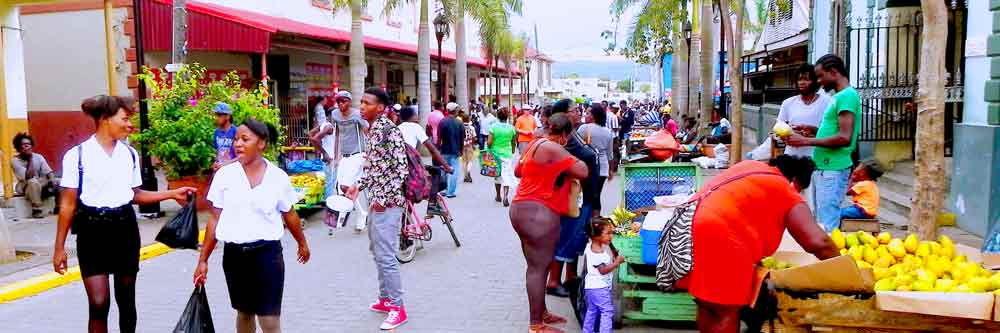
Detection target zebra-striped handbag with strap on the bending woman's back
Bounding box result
[656,171,783,290]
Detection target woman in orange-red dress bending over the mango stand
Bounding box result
[676,155,839,333]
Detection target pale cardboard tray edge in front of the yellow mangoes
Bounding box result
[875,291,996,320]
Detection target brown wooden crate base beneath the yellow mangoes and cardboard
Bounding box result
[764,291,1000,333]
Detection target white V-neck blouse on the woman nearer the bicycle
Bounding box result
[208,161,297,244]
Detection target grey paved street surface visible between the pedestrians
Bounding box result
[0,172,690,333]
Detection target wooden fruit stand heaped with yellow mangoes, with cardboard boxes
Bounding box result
[757,229,1000,332]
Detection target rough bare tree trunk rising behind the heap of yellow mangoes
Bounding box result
[910,0,948,240]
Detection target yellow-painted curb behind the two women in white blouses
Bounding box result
[0,229,205,304]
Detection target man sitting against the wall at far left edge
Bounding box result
[10,133,59,218]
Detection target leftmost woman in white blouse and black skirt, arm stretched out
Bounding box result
[52,95,195,332]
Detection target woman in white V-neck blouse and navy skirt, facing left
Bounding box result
[194,119,309,333]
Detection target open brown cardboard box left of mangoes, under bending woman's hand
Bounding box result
[771,252,875,293]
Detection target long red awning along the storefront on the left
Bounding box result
[143,0,518,73]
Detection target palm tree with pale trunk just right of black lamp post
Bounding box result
[441,0,523,110]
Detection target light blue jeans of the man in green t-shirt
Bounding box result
[813,169,851,232]
